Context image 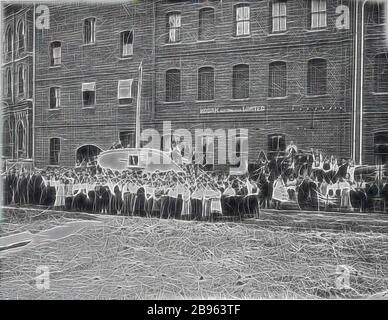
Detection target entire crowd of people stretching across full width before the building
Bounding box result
[2,147,388,220]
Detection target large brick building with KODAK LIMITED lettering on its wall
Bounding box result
[3,0,388,167]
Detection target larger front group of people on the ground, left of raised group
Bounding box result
[3,166,259,220]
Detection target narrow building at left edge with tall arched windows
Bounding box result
[2,5,33,169]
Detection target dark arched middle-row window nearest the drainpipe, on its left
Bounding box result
[307,59,327,96]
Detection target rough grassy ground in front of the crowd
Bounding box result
[0,209,388,299]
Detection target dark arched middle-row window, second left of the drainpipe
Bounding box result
[268,61,287,98]
